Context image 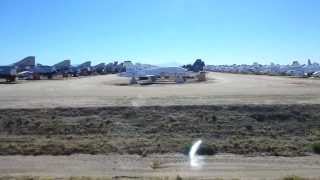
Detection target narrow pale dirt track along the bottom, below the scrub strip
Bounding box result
[0,154,320,179]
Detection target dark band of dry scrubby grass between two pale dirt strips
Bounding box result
[0,105,320,156]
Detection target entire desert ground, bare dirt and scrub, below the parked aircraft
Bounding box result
[0,73,320,180]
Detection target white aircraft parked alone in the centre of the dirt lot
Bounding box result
[120,63,190,84]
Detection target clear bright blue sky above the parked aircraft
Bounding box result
[0,0,320,65]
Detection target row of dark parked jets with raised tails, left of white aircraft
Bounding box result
[0,56,111,82]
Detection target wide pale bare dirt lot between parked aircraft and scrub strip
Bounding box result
[0,73,320,108]
